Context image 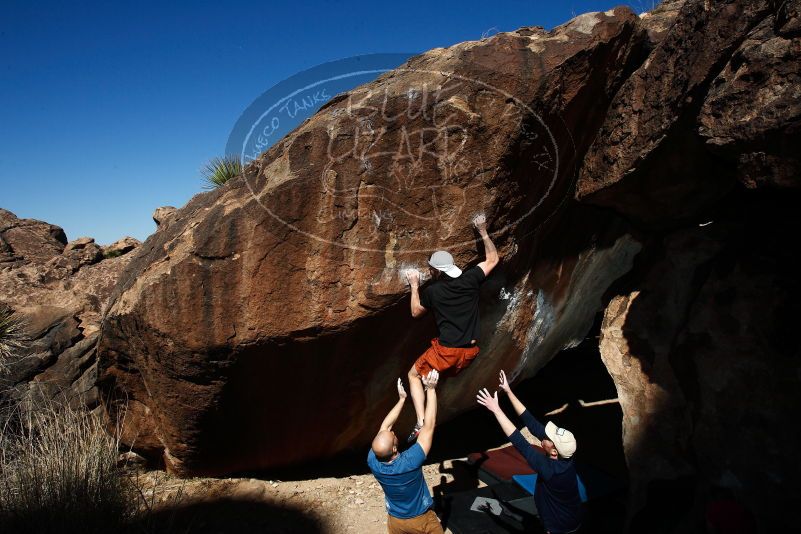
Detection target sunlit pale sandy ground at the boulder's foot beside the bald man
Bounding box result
[134,460,483,534]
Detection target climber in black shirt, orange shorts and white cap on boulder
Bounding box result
[406,215,498,443]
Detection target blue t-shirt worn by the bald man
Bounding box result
[367,443,433,519]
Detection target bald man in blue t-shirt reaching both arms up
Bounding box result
[367,371,442,534]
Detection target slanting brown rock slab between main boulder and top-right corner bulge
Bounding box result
[577,1,780,224]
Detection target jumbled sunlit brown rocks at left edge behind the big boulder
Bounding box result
[0,209,138,416]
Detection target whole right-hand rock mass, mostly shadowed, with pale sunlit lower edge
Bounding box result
[577,1,801,532]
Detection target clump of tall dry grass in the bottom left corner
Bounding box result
[0,404,137,534]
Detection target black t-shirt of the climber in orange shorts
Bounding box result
[420,265,486,347]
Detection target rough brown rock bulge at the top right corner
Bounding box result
[698,7,801,188]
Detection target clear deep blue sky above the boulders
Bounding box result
[0,0,636,244]
